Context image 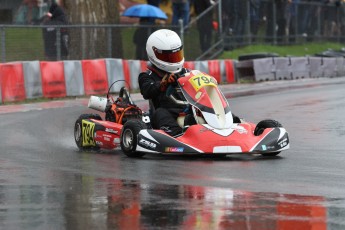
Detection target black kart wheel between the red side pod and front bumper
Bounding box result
[120,120,146,158]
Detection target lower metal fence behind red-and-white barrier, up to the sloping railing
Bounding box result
[0,0,222,62]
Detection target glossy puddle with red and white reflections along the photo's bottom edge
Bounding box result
[0,176,345,229]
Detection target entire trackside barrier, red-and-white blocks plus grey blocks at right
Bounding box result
[0,57,345,104]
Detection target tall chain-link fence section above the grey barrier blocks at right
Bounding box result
[222,0,345,50]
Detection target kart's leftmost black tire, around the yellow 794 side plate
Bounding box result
[74,114,102,151]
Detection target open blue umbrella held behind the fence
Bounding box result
[122,4,168,19]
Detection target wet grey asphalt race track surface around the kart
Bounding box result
[0,78,345,229]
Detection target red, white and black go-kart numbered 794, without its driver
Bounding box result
[74,70,290,157]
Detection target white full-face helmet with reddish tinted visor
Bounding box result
[146,29,184,73]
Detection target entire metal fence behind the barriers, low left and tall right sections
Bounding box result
[0,0,345,62]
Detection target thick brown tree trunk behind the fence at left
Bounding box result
[61,0,122,59]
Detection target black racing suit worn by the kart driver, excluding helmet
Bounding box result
[138,65,189,136]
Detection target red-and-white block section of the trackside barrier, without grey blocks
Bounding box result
[0,59,237,104]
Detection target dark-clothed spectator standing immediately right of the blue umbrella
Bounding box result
[171,0,190,26]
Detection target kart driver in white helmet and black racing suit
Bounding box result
[138,29,189,136]
